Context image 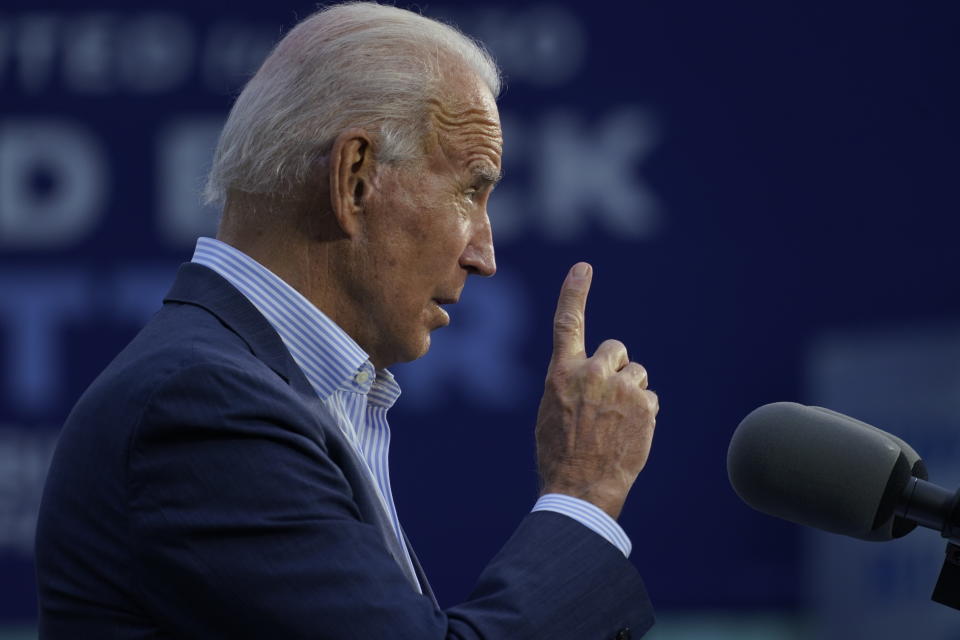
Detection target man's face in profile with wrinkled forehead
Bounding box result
[357,72,502,367]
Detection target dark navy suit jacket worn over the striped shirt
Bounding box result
[36,264,653,640]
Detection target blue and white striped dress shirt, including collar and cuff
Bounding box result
[193,238,631,574]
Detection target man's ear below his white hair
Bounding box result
[329,129,377,237]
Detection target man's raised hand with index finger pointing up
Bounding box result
[536,262,659,518]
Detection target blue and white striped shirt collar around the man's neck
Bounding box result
[192,238,400,408]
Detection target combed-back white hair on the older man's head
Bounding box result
[203,2,501,203]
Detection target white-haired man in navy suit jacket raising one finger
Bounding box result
[37,3,657,640]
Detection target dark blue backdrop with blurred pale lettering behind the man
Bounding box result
[0,0,960,639]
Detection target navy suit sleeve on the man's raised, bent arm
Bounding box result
[127,365,652,640]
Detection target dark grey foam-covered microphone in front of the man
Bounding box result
[727,402,960,541]
